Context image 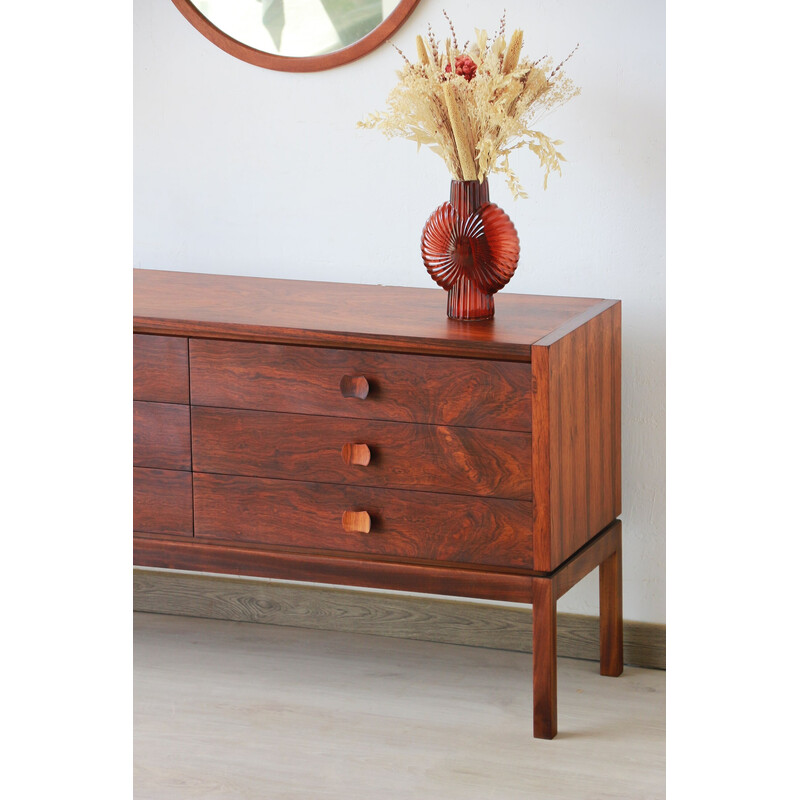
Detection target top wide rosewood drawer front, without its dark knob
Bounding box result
[189,339,531,431]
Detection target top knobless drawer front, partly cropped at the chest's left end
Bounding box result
[133,333,189,403]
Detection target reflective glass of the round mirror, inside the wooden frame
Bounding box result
[192,0,399,58]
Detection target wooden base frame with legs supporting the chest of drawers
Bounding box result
[134,520,623,739]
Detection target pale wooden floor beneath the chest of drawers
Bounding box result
[133,613,665,800]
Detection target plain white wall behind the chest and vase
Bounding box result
[134,0,665,622]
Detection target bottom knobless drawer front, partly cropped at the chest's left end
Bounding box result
[133,467,193,536]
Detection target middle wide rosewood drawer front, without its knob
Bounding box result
[192,407,531,500]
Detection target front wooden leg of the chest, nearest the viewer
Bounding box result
[533,578,558,739]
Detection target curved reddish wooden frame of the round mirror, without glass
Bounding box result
[172,0,419,72]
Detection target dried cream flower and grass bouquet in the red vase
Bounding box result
[358,13,580,198]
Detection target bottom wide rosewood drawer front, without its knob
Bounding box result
[194,473,533,568]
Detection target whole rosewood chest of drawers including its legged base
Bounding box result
[133,270,622,738]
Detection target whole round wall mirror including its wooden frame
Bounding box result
[172,0,419,72]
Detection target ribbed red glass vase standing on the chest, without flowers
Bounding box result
[422,180,519,320]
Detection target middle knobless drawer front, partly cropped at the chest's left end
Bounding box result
[133,400,192,470]
